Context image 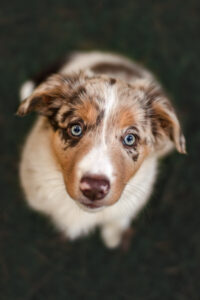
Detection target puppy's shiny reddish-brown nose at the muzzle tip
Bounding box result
[80,175,110,201]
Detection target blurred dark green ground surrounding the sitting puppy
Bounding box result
[0,0,200,300]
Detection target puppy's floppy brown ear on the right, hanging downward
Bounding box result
[148,84,186,156]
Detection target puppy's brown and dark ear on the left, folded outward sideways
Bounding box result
[17,74,75,116]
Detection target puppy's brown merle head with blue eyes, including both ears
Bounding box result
[18,74,185,210]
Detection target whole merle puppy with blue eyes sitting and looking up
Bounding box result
[17,52,186,248]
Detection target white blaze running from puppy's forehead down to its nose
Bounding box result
[78,86,116,182]
